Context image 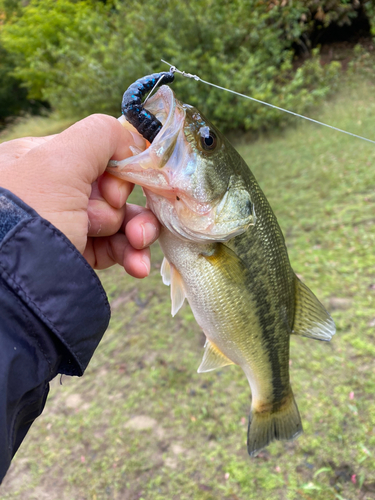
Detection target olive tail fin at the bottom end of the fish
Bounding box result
[247,392,302,457]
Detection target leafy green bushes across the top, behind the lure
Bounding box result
[1,0,370,130]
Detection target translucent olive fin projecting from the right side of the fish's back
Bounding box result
[292,278,336,341]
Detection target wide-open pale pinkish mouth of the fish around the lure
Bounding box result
[107,85,185,197]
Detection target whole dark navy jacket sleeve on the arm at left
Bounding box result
[0,188,110,483]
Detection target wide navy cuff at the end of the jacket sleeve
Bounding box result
[0,188,110,375]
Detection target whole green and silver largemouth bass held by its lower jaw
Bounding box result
[107,75,335,456]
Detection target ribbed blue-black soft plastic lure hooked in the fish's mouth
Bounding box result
[121,72,174,142]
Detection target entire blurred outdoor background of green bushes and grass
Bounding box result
[0,0,375,500]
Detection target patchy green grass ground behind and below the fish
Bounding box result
[1,80,375,500]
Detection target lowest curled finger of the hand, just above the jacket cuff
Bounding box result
[83,233,151,278]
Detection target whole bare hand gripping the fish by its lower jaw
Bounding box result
[0,115,160,278]
